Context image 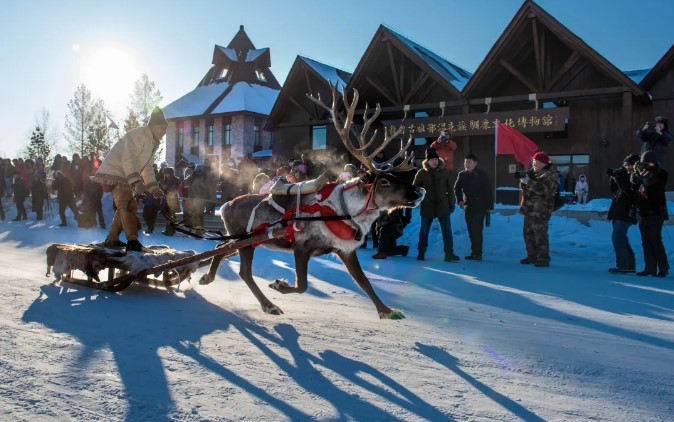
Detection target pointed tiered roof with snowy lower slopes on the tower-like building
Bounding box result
[164,25,281,119]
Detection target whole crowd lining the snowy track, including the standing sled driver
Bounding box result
[0,108,672,277]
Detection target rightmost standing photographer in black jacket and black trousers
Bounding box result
[631,151,669,277]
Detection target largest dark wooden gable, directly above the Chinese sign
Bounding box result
[463,0,644,98]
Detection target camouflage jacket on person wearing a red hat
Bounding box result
[520,164,559,218]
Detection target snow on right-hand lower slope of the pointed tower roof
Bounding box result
[213,82,280,115]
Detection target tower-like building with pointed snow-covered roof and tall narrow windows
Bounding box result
[164,25,281,165]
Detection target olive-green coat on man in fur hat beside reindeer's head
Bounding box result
[412,160,456,218]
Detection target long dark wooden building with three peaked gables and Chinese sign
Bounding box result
[267,0,674,197]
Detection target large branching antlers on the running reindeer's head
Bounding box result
[307,84,414,172]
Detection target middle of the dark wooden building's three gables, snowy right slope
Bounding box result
[348,25,471,106]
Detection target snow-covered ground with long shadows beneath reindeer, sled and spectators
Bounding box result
[0,196,674,421]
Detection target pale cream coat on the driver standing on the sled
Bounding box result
[91,126,160,191]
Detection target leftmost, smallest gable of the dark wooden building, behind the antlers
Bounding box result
[265,56,351,130]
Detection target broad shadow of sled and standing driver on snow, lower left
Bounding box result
[22,285,308,421]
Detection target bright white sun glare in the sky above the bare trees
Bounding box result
[85,48,140,108]
